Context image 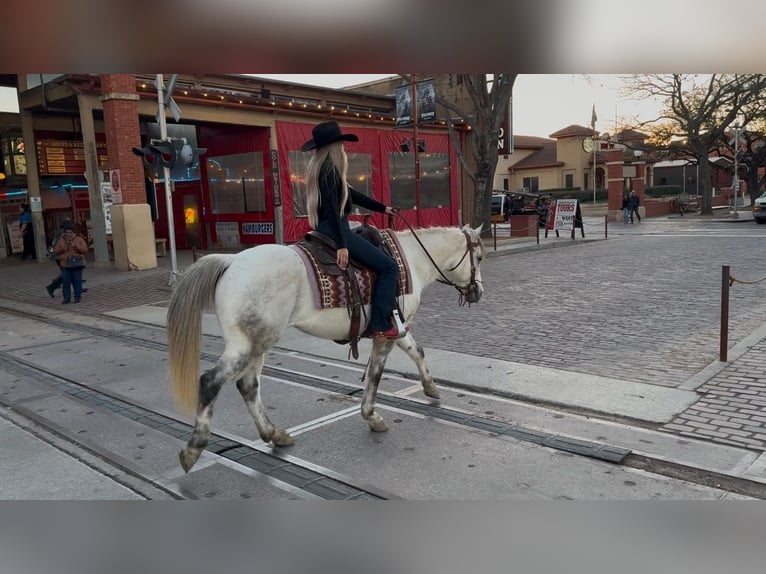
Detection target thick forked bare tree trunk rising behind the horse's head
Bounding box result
[400,74,518,232]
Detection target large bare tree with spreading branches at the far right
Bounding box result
[626,74,766,215]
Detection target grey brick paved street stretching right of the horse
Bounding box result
[413,220,766,386]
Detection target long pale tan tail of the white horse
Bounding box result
[167,254,234,414]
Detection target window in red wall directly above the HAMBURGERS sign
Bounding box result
[205,152,266,213]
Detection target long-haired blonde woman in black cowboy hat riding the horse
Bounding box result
[301,122,403,339]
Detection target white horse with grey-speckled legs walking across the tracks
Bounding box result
[167,225,484,472]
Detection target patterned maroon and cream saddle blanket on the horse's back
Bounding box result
[290,229,412,309]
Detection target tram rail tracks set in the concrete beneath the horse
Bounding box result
[0,304,766,499]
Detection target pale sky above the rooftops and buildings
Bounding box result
[0,74,660,137]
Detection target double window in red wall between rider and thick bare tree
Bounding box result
[389,152,452,209]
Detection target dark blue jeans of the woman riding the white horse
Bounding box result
[317,220,398,331]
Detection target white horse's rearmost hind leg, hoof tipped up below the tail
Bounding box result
[178,354,249,472]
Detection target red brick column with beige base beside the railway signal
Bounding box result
[101,74,157,271]
